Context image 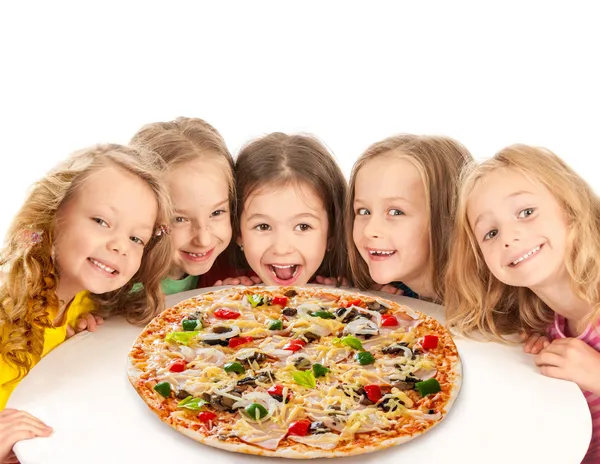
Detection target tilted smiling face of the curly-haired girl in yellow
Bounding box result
[54,165,158,301]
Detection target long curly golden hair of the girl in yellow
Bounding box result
[0,144,171,373]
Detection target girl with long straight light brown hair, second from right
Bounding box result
[346,134,472,302]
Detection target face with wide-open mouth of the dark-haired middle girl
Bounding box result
[240,184,328,285]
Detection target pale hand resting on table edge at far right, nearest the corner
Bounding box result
[535,338,600,394]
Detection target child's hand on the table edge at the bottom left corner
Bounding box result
[0,409,52,463]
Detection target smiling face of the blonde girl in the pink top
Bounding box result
[467,168,568,288]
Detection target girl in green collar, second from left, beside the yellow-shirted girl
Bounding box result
[131,117,235,295]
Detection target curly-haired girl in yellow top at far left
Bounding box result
[0,145,171,462]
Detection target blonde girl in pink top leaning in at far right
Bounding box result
[445,145,600,464]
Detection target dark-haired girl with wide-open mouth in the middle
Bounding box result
[225,132,348,285]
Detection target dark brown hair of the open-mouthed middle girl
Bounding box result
[234,132,349,282]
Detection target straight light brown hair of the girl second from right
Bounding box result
[346,134,473,301]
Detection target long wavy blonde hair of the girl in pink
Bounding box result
[445,145,600,341]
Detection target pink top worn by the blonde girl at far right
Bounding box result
[550,314,600,464]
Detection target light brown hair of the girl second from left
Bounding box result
[131,117,236,216]
